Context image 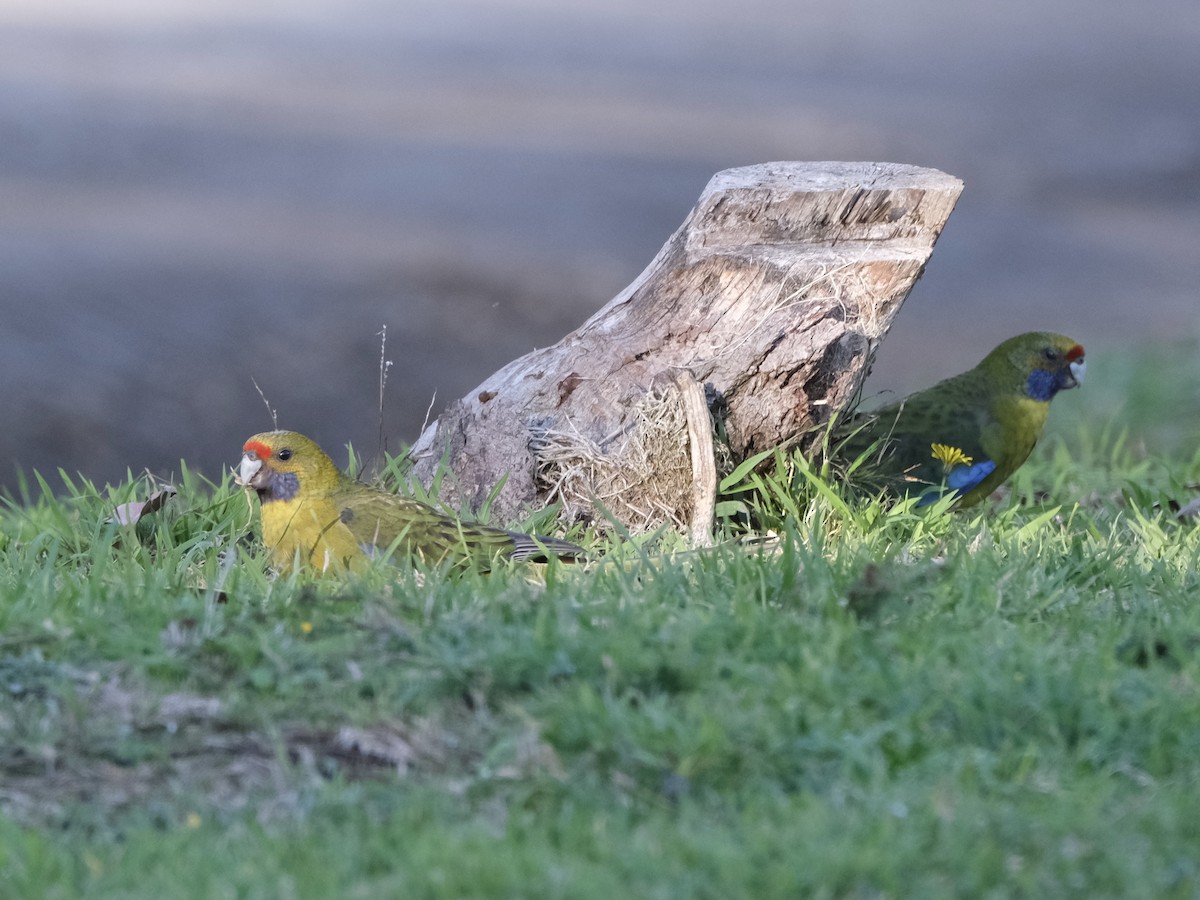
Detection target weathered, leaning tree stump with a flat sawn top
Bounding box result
[410,162,962,530]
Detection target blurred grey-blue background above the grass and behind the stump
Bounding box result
[0,0,1200,494]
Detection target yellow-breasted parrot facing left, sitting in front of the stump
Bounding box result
[238,431,583,572]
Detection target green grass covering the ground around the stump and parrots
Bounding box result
[0,340,1200,898]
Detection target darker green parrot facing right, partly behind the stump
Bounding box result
[832,331,1085,506]
